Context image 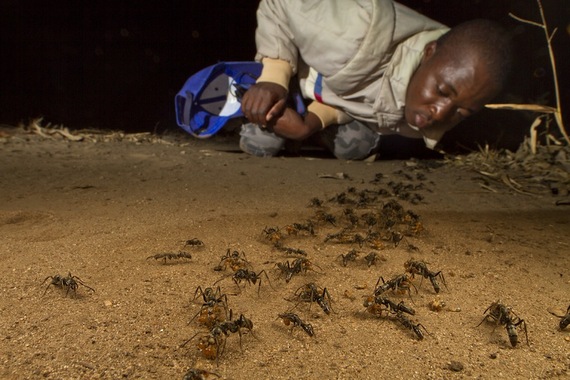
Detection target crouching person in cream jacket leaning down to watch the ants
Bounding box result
[240,0,512,160]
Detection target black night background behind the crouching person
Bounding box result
[0,0,570,148]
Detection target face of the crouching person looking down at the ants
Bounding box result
[404,41,497,130]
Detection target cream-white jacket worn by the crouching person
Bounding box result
[256,0,448,148]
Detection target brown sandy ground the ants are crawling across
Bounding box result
[0,131,570,379]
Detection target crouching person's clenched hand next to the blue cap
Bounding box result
[241,82,287,125]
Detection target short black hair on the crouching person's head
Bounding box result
[437,19,514,91]
